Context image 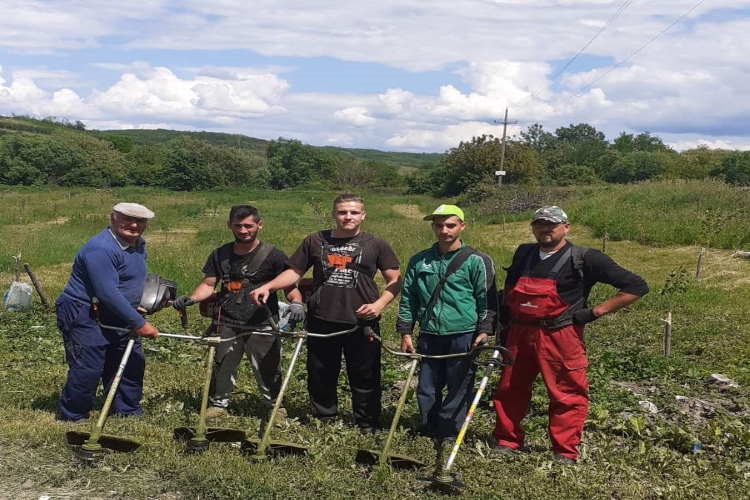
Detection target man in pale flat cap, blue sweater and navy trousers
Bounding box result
[56,203,158,422]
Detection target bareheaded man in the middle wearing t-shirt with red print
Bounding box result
[251,194,401,433]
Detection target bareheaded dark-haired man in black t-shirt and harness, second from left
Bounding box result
[173,205,305,418]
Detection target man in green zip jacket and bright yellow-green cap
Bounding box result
[396,205,497,472]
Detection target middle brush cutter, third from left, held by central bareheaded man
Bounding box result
[241,314,358,462]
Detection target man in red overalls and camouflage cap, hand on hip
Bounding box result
[493,206,648,463]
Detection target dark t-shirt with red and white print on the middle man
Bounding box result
[287,230,399,324]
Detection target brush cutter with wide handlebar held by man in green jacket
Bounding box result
[355,332,494,469]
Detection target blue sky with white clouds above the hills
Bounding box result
[0,0,750,152]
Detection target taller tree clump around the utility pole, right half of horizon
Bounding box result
[407,123,750,196]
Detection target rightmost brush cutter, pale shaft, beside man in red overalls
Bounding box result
[431,345,513,494]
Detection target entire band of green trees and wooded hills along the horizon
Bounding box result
[0,117,750,192]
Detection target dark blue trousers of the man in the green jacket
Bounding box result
[417,333,476,439]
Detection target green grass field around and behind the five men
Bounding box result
[0,186,750,499]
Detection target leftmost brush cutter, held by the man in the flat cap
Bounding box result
[65,335,141,465]
